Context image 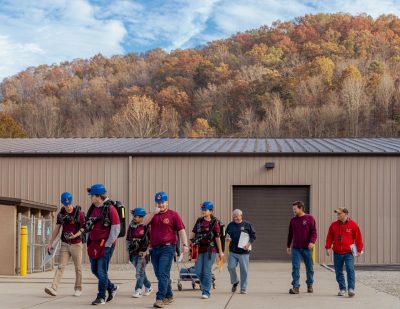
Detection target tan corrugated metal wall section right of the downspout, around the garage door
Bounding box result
[132,157,400,264]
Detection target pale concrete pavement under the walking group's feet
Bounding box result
[0,263,400,309]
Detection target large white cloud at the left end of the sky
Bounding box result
[0,0,127,78]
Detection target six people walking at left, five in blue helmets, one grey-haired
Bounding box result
[45,184,256,308]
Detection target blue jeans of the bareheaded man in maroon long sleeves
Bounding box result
[292,248,314,288]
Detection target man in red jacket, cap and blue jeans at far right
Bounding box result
[325,207,364,297]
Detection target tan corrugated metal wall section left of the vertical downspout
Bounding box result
[0,157,128,263]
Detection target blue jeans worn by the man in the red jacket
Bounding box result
[333,253,356,290]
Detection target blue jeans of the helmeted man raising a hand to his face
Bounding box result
[151,245,176,300]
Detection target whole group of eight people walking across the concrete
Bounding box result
[45,184,363,308]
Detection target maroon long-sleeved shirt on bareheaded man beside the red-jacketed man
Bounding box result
[287,214,317,249]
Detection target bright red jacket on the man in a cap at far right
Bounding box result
[325,218,364,254]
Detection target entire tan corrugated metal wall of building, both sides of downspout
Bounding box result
[0,157,400,264]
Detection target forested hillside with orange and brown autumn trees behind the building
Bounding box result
[0,14,400,137]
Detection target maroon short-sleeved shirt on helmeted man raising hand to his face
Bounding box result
[150,209,185,247]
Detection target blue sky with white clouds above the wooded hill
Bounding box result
[0,0,400,79]
